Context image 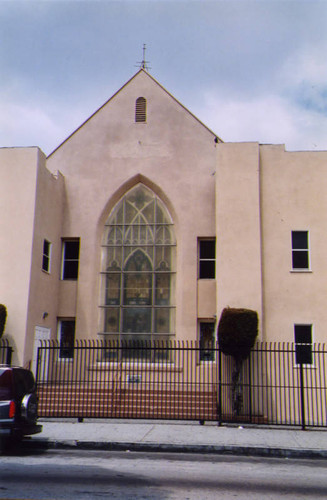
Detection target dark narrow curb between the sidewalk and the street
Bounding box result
[23,439,327,460]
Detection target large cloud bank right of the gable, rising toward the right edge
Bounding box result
[191,40,327,150]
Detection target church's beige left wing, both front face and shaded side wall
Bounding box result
[0,148,63,366]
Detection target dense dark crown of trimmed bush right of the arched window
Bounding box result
[218,308,258,360]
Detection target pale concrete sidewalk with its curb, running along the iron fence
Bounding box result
[26,419,327,459]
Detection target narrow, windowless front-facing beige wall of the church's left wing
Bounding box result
[0,148,39,362]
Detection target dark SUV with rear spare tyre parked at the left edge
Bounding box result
[0,365,42,439]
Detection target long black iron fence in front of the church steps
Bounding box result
[37,340,327,429]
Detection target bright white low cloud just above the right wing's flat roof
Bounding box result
[195,91,327,151]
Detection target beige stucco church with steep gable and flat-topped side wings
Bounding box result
[0,68,327,366]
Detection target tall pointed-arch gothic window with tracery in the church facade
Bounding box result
[101,184,176,341]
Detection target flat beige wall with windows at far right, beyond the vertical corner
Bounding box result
[260,146,327,342]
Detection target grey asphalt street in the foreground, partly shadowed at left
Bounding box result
[0,448,327,500]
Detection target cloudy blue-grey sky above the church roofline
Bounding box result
[0,0,327,155]
